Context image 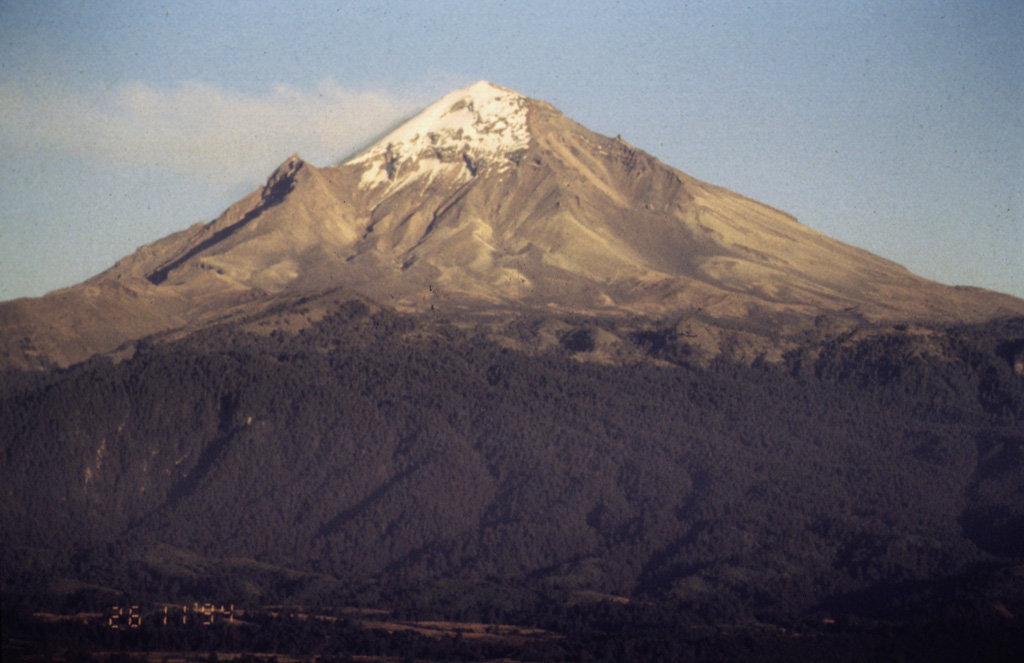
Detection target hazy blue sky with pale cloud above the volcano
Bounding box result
[0,0,1024,299]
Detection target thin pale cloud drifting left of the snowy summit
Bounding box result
[0,80,417,184]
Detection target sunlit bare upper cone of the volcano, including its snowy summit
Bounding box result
[0,82,1024,368]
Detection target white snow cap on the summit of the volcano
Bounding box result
[348,81,529,189]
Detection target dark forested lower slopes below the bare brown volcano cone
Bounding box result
[0,299,1024,660]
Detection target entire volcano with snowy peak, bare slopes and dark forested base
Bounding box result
[0,82,1024,661]
